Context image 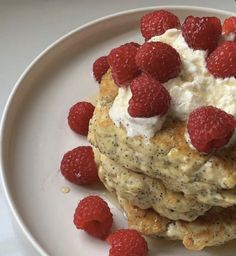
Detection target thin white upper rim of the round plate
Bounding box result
[0,5,236,256]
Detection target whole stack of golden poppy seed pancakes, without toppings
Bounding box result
[88,71,236,250]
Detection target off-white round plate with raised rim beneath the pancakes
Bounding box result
[1,7,236,256]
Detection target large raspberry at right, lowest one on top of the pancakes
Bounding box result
[187,106,235,153]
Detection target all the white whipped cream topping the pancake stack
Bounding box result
[110,28,236,137]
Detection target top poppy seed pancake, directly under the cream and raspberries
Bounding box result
[88,71,236,207]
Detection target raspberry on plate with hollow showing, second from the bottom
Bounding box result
[74,196,113,239]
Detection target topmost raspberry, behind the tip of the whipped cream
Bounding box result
[140,10,180,40]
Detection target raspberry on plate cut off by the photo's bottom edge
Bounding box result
[107,229,148,256]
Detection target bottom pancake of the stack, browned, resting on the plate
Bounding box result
[118,197,236,251]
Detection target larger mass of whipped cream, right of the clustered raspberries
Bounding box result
[150,29,236,121]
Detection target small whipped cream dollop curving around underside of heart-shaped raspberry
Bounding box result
[109,87,165,138]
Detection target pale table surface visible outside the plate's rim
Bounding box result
[0,0,236,256]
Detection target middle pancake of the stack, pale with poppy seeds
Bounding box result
[99,151,211,221]
